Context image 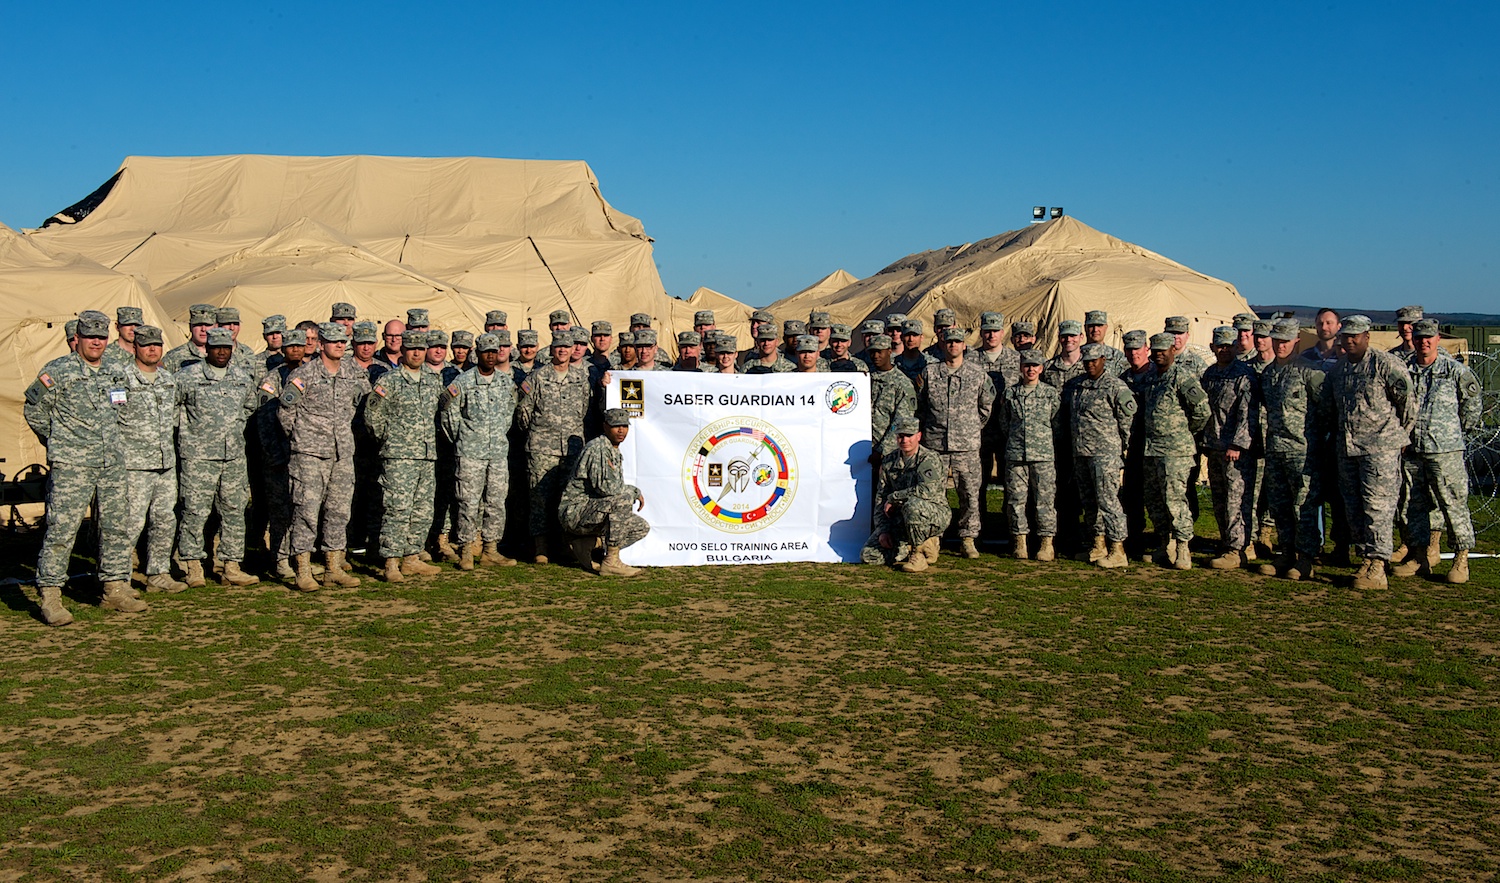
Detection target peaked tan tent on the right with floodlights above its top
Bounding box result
[770,217,1250,352]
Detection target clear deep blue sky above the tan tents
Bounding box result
[0,1,1500,312]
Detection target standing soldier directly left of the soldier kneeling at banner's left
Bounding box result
[516,328,594,564]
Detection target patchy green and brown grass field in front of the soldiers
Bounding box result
[0,512,1500,880]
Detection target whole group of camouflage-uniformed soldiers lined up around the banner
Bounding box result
[26,303,1479,625]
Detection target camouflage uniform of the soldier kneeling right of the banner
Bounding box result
[860,443,953,564]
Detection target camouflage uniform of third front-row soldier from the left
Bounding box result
[173,361,260,561]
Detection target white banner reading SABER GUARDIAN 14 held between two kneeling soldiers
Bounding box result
[606,370,872,565]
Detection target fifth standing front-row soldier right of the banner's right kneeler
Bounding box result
[1199,325,1260,570]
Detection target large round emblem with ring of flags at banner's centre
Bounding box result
[683,417,797,532]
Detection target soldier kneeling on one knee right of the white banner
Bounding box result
[860,419,953,573]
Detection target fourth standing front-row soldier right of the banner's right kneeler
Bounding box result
[1140,331,1209,570]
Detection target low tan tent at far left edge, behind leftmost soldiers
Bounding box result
[0,223,174,480]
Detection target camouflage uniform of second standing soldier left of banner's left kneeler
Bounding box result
[438,369,516,546]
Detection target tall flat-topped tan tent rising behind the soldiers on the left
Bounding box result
[32,156,671,328]
